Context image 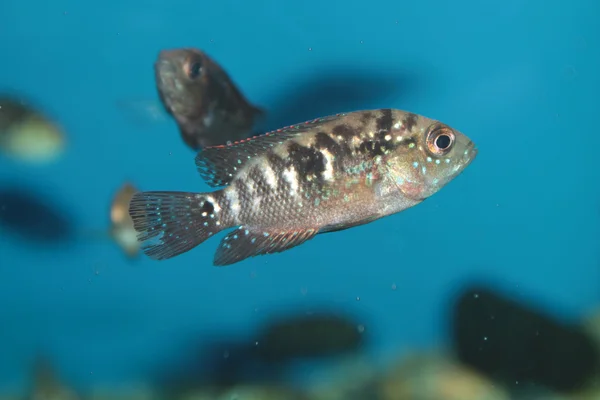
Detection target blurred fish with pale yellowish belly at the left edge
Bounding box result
[0,94,65,165]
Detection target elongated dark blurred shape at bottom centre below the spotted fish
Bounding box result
[159,310,368,395]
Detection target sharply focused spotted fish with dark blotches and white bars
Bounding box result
[129,108,477,266]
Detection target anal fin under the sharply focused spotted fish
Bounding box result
[213,226,319,266]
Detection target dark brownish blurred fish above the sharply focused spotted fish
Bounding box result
[154,48,266,151]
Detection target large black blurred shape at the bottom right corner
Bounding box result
[452,287,600,392]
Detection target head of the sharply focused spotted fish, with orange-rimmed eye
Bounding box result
[386,111,477,201]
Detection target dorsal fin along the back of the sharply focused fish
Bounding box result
[196,114,345,187]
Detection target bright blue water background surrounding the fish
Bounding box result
[0,0,600,386]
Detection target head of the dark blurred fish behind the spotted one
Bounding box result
[154,49,214,119]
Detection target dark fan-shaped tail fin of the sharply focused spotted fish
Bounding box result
[129,192,226,260]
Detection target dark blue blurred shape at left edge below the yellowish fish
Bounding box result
[0,184,73,244]
